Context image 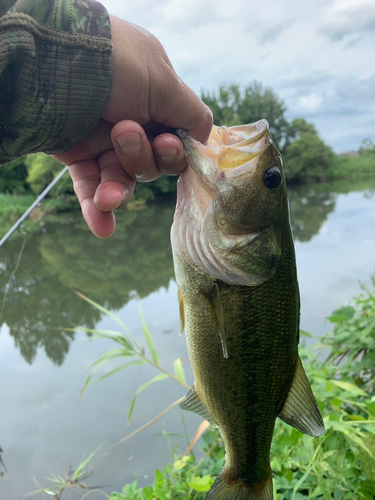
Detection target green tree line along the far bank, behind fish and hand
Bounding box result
[0,82,375,201]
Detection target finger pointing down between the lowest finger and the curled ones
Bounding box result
[94,149,135,212]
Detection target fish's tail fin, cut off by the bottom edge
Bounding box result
[204,472,273,500]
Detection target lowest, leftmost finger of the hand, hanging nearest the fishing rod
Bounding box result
[69,160,116,238]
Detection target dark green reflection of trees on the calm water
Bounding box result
[0,179,375,365]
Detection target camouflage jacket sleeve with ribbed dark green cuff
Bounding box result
[0,0,112,164]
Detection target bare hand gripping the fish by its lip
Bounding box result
[54,16,212,238]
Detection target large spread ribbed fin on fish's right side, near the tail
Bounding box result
[279,356,325,437]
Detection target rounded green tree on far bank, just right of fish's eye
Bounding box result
[283,118,335,182]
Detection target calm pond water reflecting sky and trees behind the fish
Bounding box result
[0,179,375,500]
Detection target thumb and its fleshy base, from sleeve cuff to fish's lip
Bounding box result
[103,16,212,143]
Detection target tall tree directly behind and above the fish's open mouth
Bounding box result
[201,81,288,147]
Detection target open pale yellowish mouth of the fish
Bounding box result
[177,120,272,175]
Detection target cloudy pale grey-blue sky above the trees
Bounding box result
[102,0,375,153]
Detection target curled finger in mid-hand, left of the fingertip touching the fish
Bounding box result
[111,120,161,182]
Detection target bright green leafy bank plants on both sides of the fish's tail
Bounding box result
[110,278,375,500]
